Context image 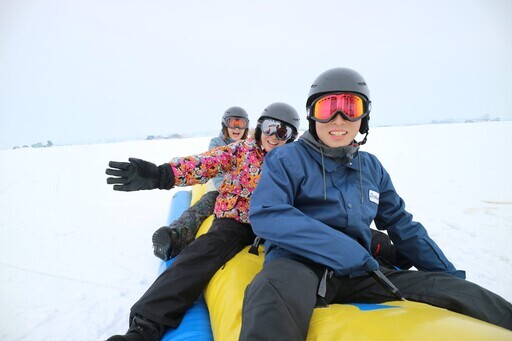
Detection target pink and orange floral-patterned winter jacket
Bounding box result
[169,138,266,223]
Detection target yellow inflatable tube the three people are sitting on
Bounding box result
[166,185,512,341]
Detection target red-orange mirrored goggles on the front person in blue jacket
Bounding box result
[309,93,370,123]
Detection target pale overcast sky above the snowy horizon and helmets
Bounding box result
[0,0,512,148]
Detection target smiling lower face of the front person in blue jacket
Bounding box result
[315,114,361,148]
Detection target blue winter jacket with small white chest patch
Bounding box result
[249,140,465,278]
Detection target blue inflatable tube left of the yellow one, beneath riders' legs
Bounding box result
[159,191,213,341]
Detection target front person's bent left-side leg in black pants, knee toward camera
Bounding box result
[240,258,318,341]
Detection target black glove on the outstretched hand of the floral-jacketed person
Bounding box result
[105,158,174,192]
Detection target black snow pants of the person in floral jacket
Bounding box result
[130,219,255,329]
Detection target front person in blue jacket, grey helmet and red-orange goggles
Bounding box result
[240,68,512,341]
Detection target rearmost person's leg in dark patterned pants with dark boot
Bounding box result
[152,191,219,261]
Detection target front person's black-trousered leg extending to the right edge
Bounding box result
[332,267,512,329]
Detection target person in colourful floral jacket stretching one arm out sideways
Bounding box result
[106,103,299,341]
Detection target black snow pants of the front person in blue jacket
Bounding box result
[240,258,512,341]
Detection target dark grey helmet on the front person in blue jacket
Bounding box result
[306,67,371,136]
